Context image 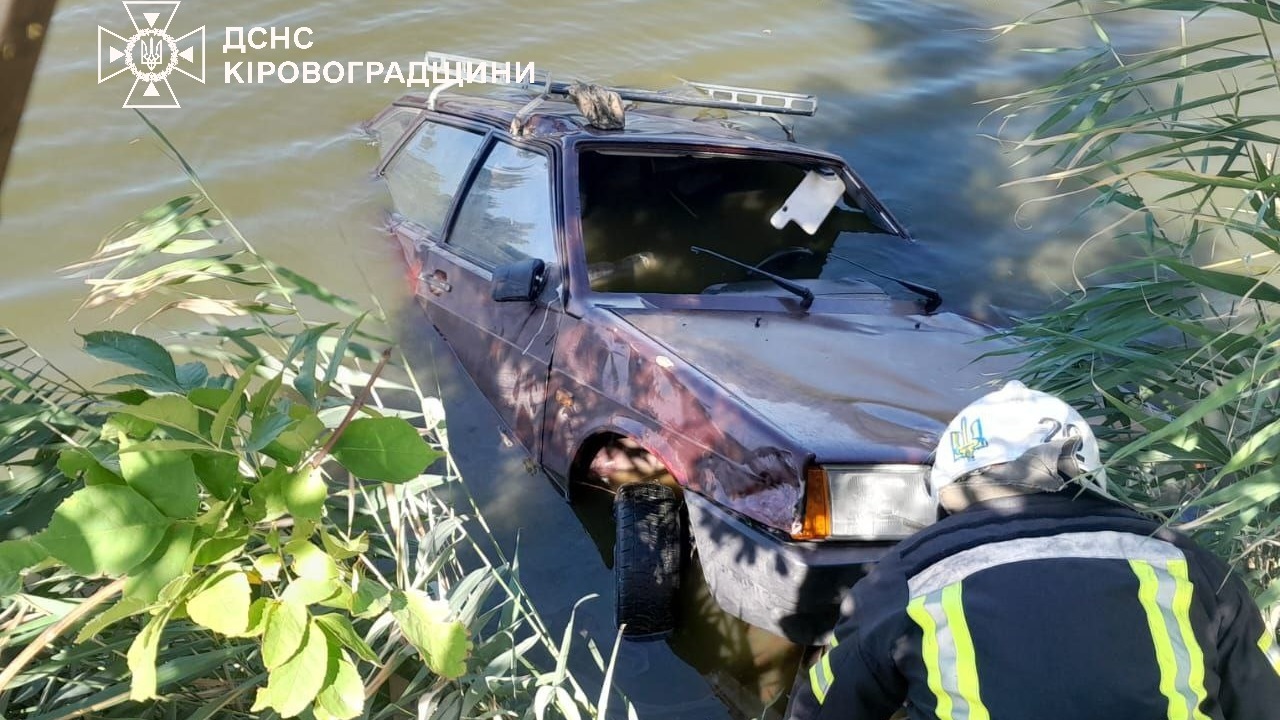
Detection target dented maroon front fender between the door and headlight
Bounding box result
[543,309,809,532]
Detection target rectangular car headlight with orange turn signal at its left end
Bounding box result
[792,465,937,541]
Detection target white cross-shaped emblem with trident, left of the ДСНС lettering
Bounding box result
[97,0,205,109]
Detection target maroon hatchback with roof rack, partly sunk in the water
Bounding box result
[367,63,1004,643]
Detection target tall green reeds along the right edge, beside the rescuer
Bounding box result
[993,0,1280,609]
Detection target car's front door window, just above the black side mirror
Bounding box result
[449,142,556,266]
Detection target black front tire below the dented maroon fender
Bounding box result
[613,483,684,639]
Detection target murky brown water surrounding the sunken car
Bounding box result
[0,0,1253,719]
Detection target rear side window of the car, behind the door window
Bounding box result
[387,122,484,237]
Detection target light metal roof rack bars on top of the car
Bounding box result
[426,53,818,117]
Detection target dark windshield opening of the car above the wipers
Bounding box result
[579,151,892,295]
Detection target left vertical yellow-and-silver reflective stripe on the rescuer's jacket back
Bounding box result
[906,583,991,720]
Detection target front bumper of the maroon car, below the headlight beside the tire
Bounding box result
[685,492,895,644]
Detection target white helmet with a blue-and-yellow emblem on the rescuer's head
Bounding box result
[929,380,1107,505]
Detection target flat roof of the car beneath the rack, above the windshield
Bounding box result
[396,90,835,159]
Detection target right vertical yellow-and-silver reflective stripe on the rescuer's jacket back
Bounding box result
[1129,560,1207,720]
